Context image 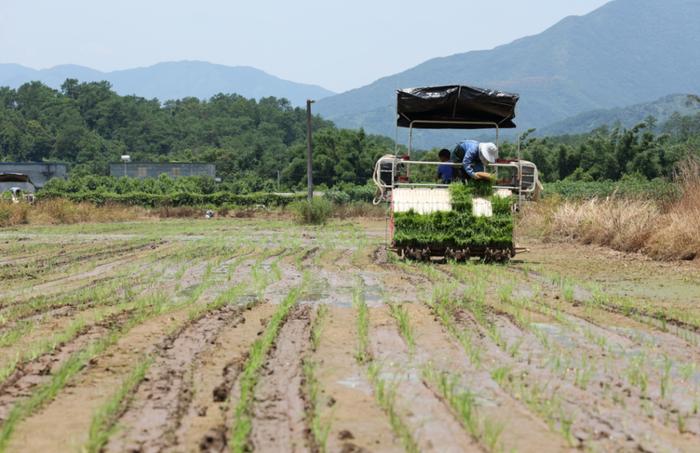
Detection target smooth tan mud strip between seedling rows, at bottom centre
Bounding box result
[300,248,404,452]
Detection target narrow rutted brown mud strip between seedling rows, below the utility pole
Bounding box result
[250,305,311,452]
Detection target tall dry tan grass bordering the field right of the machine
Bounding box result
[519,160,700,260]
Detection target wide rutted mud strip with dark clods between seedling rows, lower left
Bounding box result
[106,256,295,451]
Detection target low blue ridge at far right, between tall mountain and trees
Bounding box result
[537,94,700,136]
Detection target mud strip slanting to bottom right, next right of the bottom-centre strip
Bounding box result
[369,307,482,452]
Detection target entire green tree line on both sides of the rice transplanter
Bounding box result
[0,79,700,189]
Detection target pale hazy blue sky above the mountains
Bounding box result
[0,0,608,91]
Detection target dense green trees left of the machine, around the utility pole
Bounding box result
[0,79,392,191]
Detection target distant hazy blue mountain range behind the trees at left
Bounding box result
[0,61,334,105]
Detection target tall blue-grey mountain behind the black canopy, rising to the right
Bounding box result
[315,0,700,144]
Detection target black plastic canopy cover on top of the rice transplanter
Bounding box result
[396,85,520,129]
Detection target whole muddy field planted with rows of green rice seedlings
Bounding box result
[0,220,700,452]
